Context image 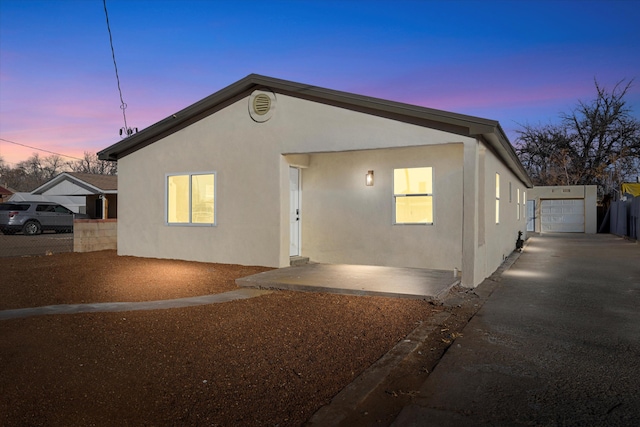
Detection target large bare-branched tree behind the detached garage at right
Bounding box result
[515,80,640,193]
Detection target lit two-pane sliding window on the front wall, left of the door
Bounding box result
[166,172,216,225]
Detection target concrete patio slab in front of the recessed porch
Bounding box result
[236,264,460,300]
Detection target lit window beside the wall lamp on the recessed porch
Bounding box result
[393,167,433,224]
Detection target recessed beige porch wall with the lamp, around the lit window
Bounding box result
[301,143,462,270]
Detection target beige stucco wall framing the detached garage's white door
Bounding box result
[527,185,598,234]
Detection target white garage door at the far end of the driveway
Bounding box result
[540,200,584,233]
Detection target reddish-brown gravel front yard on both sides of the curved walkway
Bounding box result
[0,251,482,426]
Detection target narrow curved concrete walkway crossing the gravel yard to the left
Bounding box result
[0,289,271,320]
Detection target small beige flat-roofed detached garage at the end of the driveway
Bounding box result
[527,185,598,234]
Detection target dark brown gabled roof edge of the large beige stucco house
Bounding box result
[98,74,533,187]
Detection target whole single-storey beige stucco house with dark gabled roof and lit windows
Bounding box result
[98,74,532,286]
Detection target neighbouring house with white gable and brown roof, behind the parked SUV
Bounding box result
[29,172,118,219]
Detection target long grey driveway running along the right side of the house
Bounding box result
[393,234,640,426]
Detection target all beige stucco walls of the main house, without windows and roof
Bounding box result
[118,94,525,286]
